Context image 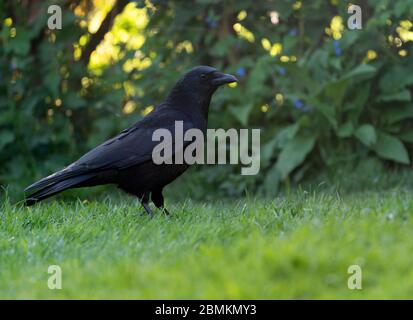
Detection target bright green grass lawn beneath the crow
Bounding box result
[0,187,413,299]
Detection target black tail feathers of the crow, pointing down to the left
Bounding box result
[25,173,95,206]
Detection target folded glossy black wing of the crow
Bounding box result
[25,105,194,191]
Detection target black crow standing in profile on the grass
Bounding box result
[25,66,237,216]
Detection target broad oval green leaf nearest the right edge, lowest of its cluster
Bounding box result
[373,132,410,164]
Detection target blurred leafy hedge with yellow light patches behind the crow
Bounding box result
[0,0,413,199]
